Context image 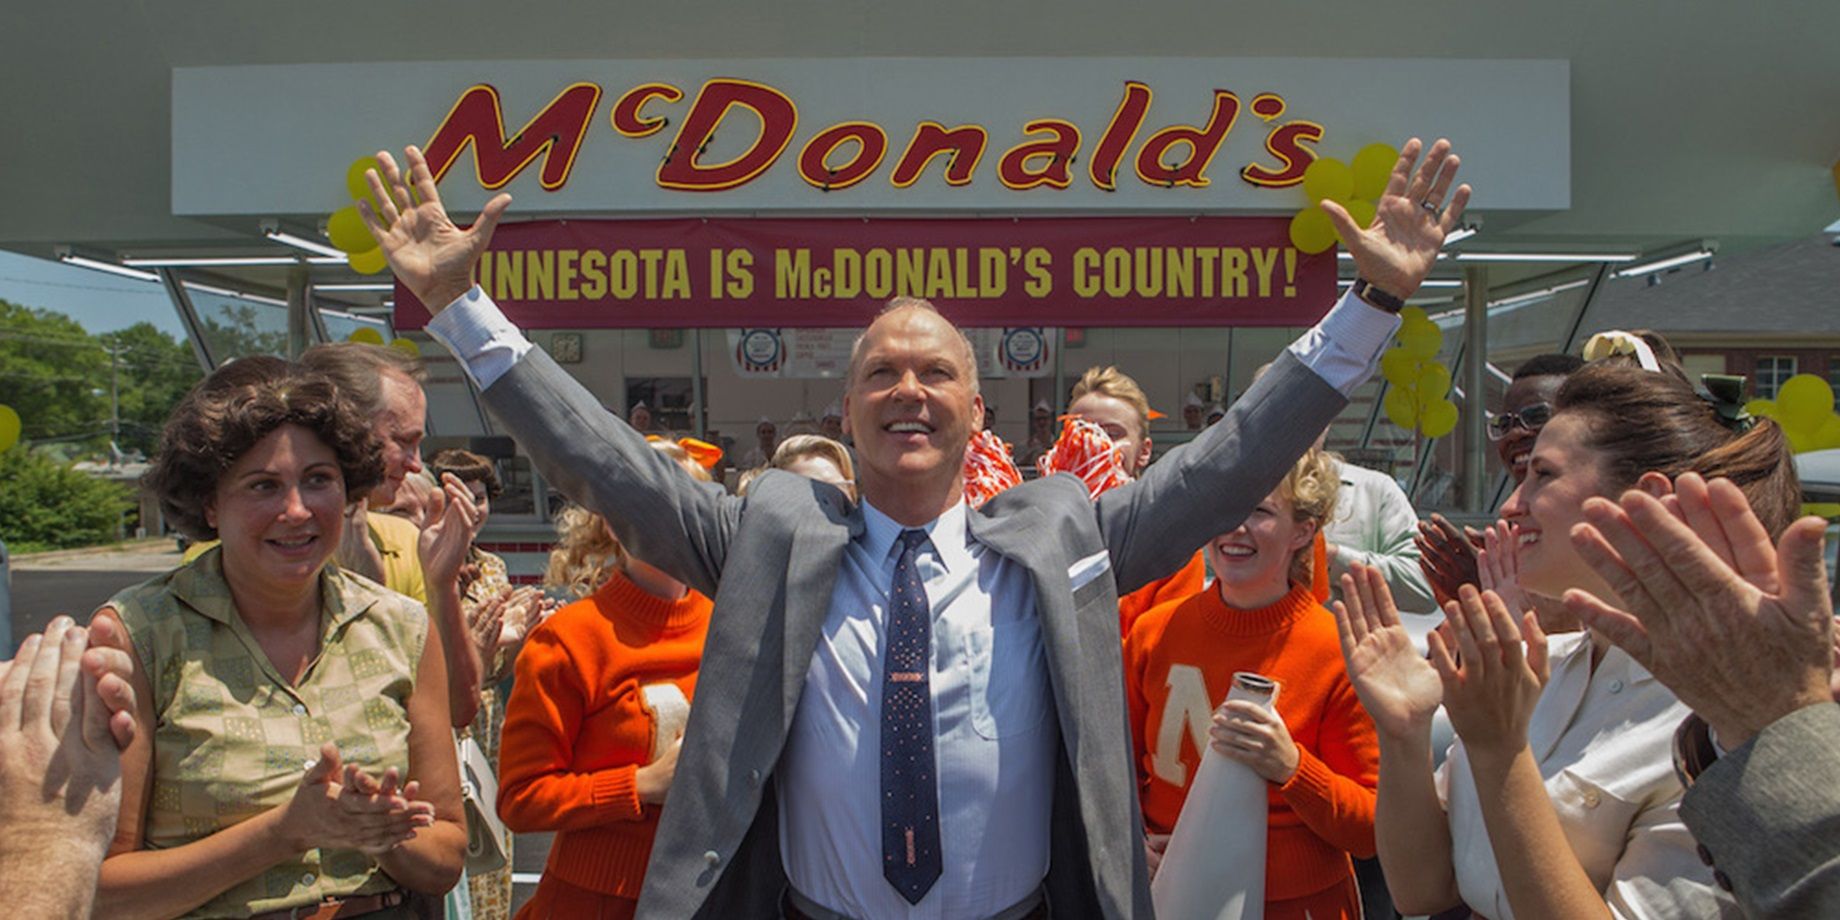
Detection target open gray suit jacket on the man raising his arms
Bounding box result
[484,351,1345,920]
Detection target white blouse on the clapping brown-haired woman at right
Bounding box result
[1437,633,1742,920]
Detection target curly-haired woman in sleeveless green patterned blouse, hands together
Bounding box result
[98,357,466,920]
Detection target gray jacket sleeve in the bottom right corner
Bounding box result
[1680,705,1840,918]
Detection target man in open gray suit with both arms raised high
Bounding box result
[366,140,1468,918]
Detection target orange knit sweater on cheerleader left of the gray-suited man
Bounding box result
[499,572,710,898]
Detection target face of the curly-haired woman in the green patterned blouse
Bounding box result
[204,425,346,585]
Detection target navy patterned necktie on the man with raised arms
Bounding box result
[881,530,940,903]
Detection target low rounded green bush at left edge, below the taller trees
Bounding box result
[0,445,134,552]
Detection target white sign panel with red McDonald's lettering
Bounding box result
[173,57,1571,215]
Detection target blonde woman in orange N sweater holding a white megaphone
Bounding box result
[1124,449,1380,920]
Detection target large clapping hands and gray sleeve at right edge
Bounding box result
[1566,473,1840,918]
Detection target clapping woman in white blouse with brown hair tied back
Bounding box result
[1338,361,1800,920]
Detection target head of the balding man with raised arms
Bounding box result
[843,307,984,508]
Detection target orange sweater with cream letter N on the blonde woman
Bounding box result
[1124,585,1380,902]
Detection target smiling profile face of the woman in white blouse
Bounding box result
[1501,412,1621,598]
